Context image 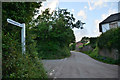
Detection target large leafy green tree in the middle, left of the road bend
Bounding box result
[33,9,78,59]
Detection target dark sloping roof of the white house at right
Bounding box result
[99,13,120,32]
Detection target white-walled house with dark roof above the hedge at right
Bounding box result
[99,12,120,33]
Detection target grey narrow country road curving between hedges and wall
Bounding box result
[42,51,118,78]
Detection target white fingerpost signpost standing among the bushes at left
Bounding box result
[7,19,25,54]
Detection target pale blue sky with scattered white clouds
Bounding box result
[37,0,119,42]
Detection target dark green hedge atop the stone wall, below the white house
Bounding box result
[97,28,120,53]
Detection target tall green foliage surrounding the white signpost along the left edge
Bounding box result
[2,2,46,78]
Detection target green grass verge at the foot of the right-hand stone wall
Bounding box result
[83,47,119,65]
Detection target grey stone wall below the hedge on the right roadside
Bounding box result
[98,48,119,60]
